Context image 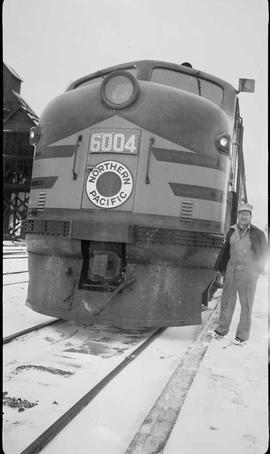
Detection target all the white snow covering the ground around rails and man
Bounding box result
[3,241,268,454]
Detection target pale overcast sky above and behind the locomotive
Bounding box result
[3,0,268,228]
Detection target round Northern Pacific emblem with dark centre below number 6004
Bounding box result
[86,161,133,208]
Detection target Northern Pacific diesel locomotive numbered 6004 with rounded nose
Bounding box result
[24,60,254,328]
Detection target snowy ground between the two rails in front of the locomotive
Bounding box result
[3,321,155,454]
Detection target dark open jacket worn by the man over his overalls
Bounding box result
[214,224,267,273]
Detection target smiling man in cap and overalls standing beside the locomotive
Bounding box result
[210,203,267,344]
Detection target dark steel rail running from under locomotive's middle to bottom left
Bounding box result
[21,328,166,454]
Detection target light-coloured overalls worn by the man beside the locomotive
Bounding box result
[216,225,258,341]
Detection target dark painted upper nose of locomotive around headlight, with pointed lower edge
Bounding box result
[34,82,229,157]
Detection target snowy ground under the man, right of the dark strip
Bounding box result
[163,276,268,454]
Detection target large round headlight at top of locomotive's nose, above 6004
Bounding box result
[100,71,139,109]
